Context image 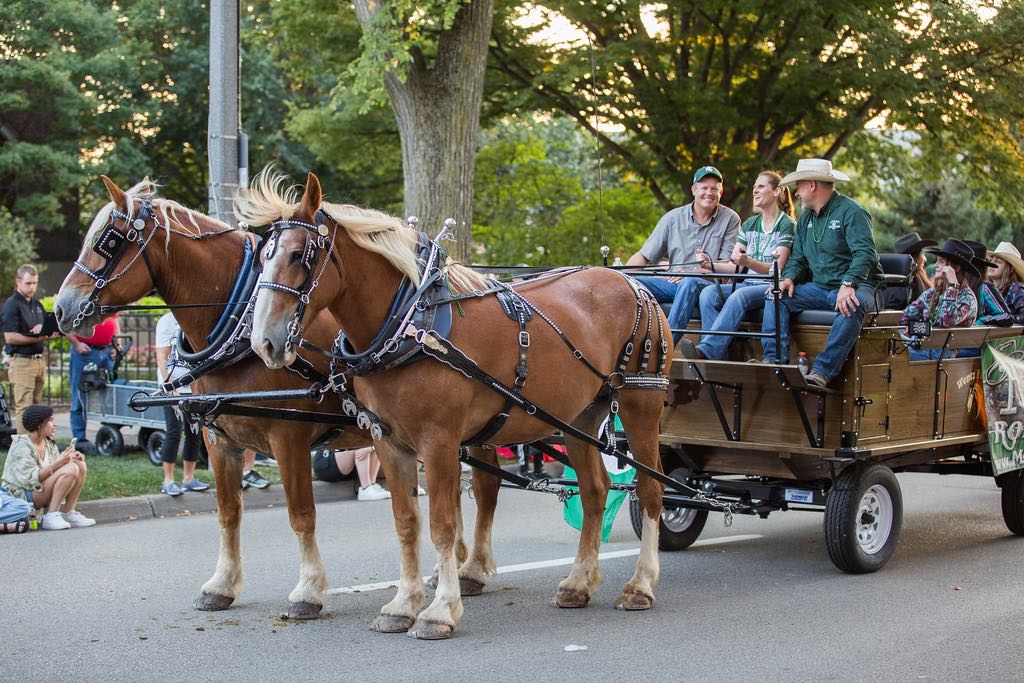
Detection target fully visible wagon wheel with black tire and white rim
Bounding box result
[824,465,903,573]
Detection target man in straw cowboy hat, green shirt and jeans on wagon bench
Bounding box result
[761,159,882,387]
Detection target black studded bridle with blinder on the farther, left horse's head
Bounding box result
[72,202,157,328]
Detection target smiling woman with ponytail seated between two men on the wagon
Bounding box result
[683,171,797,360]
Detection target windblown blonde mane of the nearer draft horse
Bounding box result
[234,166,489,294]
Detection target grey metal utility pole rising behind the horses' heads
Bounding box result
[207,0,249,224]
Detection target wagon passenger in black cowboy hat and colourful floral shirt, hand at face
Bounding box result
[900,240,978,360]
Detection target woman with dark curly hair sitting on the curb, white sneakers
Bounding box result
[2,403,96,529]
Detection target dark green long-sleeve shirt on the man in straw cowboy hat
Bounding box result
[782,191,882,290]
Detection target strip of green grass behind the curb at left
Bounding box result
[0,439,281,501]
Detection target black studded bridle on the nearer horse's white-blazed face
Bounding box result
[256,209,338,351]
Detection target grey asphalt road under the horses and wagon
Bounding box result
[0,474,1024,681]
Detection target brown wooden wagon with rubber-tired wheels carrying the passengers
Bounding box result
[631,310,1024,573]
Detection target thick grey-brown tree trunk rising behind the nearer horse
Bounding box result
[353,0,494,260]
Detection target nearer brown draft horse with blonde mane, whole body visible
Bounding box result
[244,174,671,639]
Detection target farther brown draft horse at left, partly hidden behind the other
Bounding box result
[55,177,371,618]
